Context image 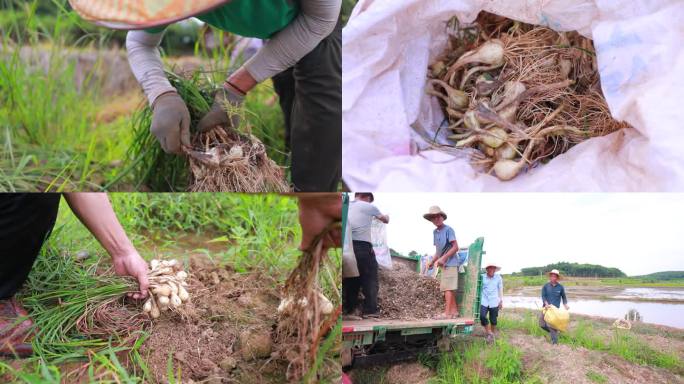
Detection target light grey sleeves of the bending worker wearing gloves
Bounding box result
[126,0,342,104]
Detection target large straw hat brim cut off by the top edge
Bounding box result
[69,0,231,29]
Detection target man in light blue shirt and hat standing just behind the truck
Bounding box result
[480,263,503,343]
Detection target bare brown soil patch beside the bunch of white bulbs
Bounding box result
[141,255,285,383]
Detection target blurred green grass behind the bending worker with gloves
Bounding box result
[0,0,288,191]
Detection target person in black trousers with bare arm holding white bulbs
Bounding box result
[0,193,149,357]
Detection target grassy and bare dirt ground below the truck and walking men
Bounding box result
[351,310,684,384]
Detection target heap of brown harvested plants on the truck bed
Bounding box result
[378,263,444,320]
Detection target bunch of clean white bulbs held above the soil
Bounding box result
[143,259,190,319]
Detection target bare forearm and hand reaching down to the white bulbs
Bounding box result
[64,193,149,299]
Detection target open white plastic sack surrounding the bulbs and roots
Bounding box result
[342,0,684,192]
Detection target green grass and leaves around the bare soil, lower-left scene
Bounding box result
[0,193,341,383]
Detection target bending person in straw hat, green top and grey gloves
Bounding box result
[70,0,342,192]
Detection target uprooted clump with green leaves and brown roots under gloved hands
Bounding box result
[128,72,290,193]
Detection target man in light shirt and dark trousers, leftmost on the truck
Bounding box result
[342,193,389,320]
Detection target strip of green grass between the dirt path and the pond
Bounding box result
[499,311,684,375]
